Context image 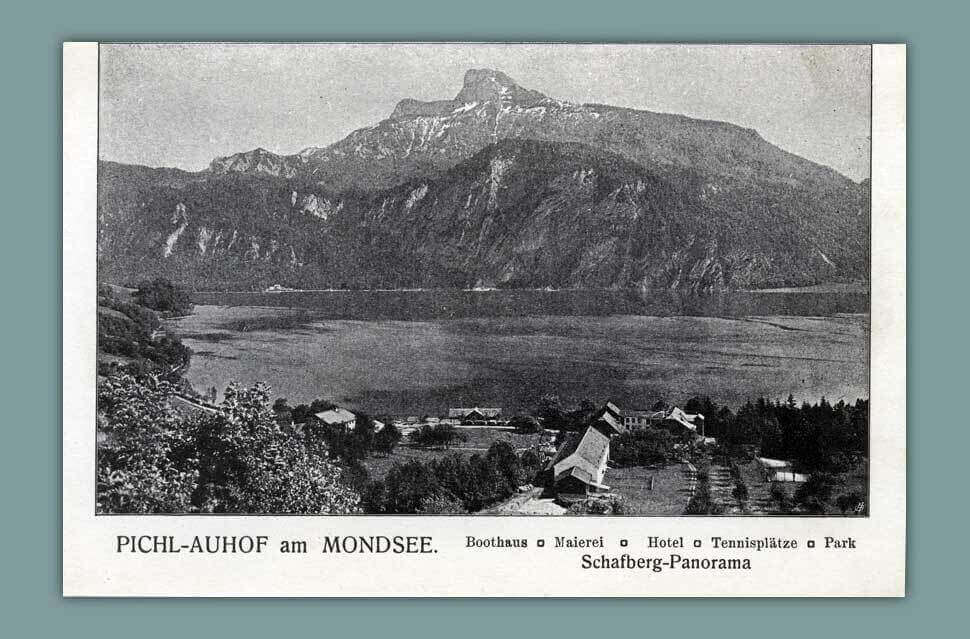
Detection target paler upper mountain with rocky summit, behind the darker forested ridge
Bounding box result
[210,69,849,190]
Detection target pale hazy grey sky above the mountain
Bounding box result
[100,44,871,180]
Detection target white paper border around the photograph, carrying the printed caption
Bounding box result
[63,43,906,597]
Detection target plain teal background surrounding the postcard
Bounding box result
[0,0,970,639]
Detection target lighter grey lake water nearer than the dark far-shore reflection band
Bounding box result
[167,306,869,415]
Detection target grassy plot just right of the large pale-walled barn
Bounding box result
[603,464,690,516]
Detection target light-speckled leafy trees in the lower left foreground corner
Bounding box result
[97,374,360,513]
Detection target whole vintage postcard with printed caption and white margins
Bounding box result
[63,43,906,597]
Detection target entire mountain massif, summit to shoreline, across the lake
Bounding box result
[99,69,869,290]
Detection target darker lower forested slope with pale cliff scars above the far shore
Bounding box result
[99,140,865,290]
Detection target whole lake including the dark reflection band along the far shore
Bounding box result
[168,291,869,414]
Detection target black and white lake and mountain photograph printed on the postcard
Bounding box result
[96,43,868,516]
